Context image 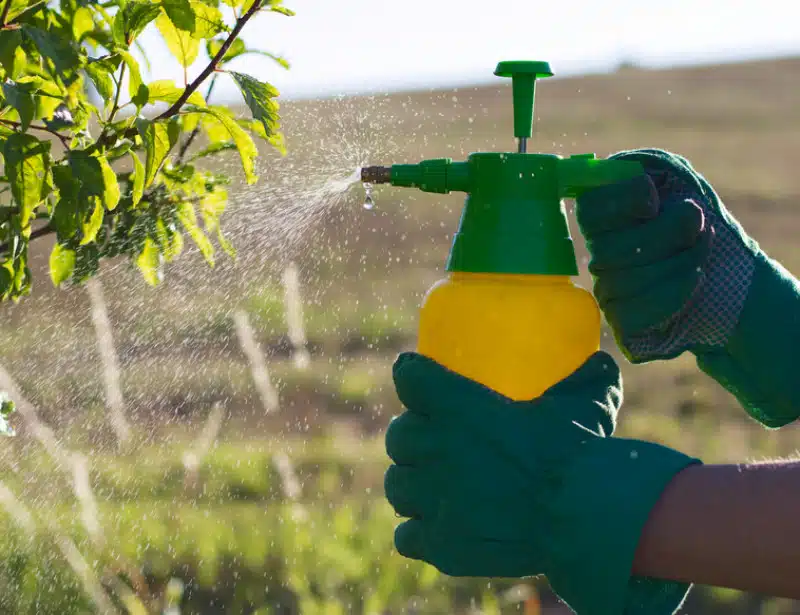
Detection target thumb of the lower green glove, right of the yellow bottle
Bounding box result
[538,350,622,436]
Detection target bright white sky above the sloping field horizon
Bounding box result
[142,0,800,102]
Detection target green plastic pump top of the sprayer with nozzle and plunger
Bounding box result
[361,61,644,276]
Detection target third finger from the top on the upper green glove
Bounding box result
[594,233,711,308]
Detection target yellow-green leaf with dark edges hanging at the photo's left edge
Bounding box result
[3,133,50,228]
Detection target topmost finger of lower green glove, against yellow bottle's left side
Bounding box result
[393,354,509,417]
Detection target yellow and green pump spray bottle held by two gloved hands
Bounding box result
[361,62,644,400]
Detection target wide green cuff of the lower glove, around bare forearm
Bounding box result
[546,438,701,615]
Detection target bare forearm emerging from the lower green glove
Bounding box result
[633,462,800,599]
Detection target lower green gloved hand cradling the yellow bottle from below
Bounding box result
[385,352,699,615]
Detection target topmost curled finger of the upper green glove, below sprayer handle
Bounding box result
[575,175,659,239]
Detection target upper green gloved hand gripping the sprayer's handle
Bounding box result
[576,149,800,427]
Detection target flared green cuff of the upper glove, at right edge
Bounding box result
[693,252,800,428]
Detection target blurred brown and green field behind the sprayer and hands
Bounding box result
[0,58,800,615]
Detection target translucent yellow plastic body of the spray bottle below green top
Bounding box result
[417,272,600,401]
